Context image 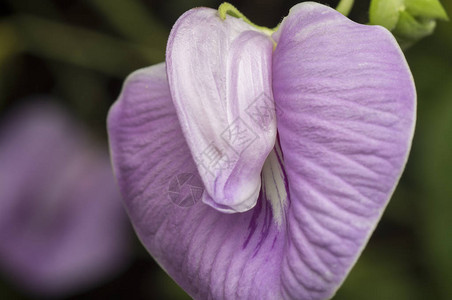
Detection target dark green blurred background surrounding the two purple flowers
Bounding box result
[0,0,452,300]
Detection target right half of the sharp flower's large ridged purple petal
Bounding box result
[273,3,416,299]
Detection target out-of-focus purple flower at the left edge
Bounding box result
[0,101,130,296]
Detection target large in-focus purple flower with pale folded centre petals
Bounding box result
[108,3,416,299]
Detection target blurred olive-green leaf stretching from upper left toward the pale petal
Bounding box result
[8,15,165,77]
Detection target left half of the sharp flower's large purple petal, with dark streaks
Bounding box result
[108,64,285,299]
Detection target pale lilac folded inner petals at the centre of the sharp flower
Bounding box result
[166,8,276,212]
